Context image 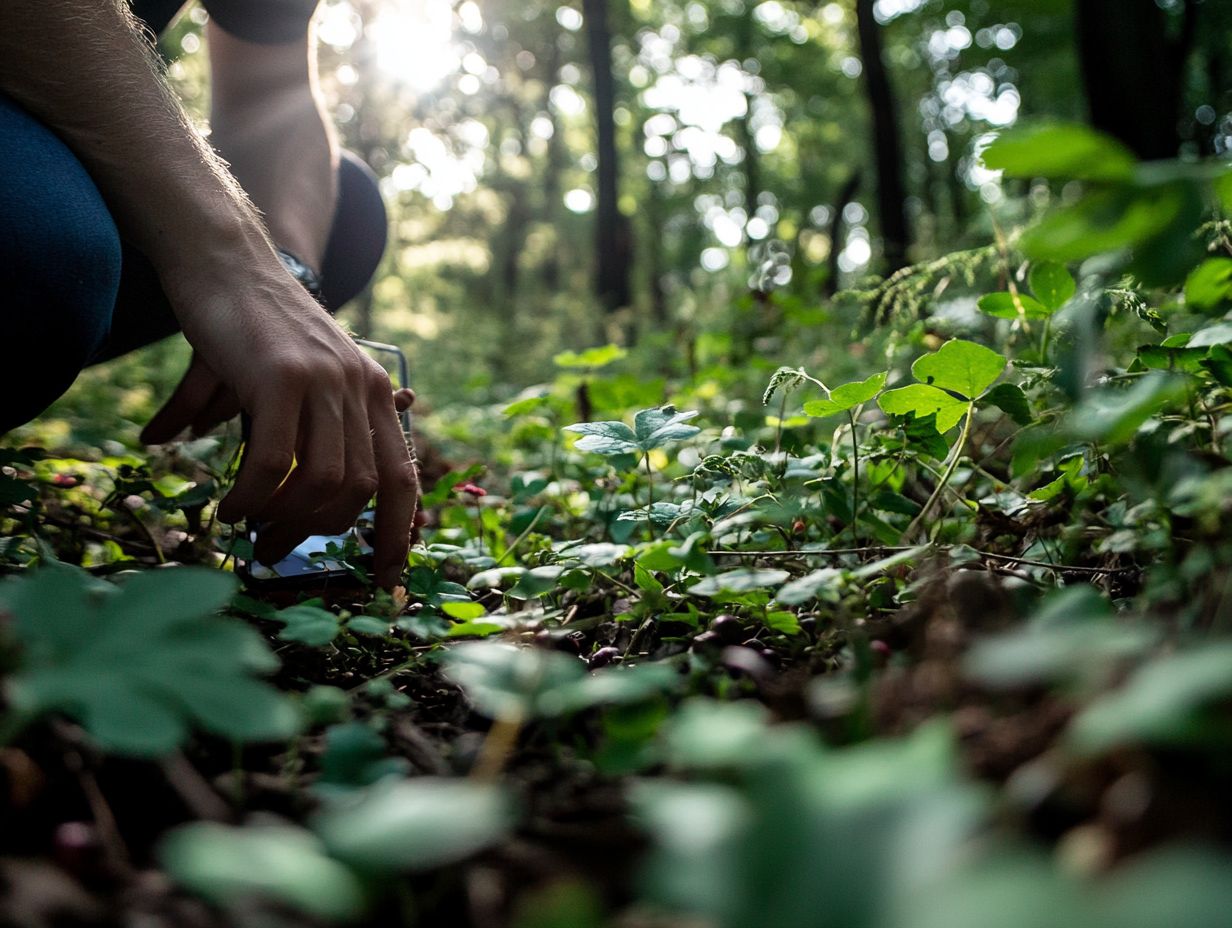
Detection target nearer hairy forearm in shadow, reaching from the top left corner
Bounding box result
[0,0,276,293]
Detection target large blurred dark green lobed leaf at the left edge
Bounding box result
[0,564,290,755]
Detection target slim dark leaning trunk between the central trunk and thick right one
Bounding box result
[855,0,910,272]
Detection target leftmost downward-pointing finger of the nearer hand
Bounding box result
[218,391,302,523]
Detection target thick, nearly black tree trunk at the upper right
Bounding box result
[1074,0,1198,160]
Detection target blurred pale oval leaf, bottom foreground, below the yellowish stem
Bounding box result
[312,776,514,873]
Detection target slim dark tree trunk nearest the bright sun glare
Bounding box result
[582,0,632,313]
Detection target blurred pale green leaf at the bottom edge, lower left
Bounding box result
[158,822,367,922]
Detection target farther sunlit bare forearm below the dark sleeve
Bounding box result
[208,23,338,270]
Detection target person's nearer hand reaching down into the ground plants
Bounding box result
[143,255,419,588]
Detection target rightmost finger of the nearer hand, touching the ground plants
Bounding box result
[368,374,419,579]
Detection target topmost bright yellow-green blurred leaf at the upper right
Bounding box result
[982,123,1136,181]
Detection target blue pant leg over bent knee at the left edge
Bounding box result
[0,95,122,434]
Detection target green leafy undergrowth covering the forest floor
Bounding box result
[7,124,1232,928]
